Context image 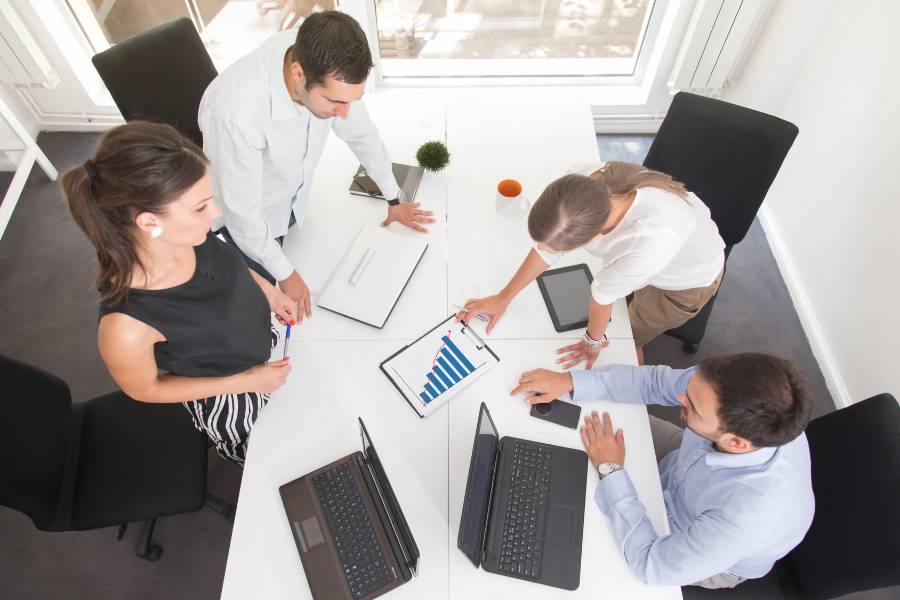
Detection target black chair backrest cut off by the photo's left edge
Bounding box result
[0,355,72,527]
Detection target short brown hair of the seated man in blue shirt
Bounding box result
[697,352,812,448]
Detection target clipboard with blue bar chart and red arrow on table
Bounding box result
[381,315,500,417]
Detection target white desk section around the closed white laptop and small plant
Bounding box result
[283,94,448,341]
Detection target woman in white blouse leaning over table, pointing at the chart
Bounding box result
[457,161,725,369]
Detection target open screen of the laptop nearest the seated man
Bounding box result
[457,402,500,567]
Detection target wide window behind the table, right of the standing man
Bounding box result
[374,0,662,82]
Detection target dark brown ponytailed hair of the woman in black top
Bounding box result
[60,121,209,304]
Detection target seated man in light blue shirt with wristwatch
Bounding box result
[512,353,815,588]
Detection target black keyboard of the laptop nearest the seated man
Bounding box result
[500,442,551,579]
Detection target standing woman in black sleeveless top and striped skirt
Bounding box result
[61,122,295,465]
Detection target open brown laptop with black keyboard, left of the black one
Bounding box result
[279,419,419,600]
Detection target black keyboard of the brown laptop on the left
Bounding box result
[313,463,394,598]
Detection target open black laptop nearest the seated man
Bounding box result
[457,402,588,590]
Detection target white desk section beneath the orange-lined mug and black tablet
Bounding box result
[447,95,632,339]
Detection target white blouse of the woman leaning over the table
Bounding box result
[534,165,725,304]
